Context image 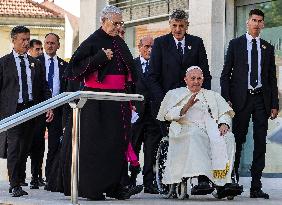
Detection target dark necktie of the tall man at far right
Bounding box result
[250,39,258,88]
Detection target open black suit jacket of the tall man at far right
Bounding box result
[220,35,279,115]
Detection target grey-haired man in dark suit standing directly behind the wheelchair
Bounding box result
[149,10,212,191]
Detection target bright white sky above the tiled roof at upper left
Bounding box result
[33,0,80,17]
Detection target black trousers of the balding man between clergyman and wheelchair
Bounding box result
[132,104,162,187]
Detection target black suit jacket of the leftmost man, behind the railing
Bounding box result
[0,53,51,157]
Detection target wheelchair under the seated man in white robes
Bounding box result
[156,137,243,200]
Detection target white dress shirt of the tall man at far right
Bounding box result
[246,33,262,89]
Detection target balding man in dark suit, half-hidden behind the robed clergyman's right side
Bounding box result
[131,36,161,194]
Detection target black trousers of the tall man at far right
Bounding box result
[233,93,269,190]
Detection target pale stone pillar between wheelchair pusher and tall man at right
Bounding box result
[188,0,234,91]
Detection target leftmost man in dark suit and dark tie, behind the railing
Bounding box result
[0,26,53,197]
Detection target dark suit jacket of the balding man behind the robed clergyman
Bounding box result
[134,57,151,119]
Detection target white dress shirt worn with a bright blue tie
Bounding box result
[44,53,60,97]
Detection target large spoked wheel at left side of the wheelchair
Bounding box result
[156,137,173,198]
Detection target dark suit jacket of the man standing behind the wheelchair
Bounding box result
[149,33,211,113]
